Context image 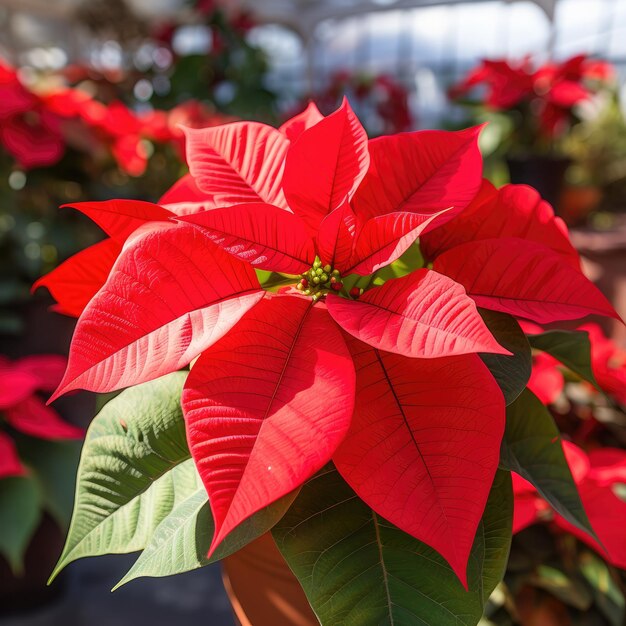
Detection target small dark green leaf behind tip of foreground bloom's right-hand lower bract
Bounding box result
[478,309,532,405]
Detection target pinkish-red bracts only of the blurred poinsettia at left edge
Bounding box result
[0,354,83,478]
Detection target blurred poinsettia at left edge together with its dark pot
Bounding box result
[0,354,84,614]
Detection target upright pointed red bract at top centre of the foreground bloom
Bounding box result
[284,99,369,232]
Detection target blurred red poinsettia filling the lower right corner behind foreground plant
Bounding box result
[487,322,626,626]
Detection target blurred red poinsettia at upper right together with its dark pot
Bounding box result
[449,55,614,207]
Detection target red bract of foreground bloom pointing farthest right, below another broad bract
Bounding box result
[433,238,619,324]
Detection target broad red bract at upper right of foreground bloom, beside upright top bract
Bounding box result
[352,128,482,227]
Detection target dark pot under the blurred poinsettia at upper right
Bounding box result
[506,155,571,210]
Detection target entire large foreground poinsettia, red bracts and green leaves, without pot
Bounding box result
[41,101,617,624]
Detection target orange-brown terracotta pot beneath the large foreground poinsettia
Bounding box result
[222,533,319,626]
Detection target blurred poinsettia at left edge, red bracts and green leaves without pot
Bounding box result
[0,354,84,573]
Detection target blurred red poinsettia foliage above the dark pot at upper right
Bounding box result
[449,54,615,154]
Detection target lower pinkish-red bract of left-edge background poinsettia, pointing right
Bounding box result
[5,396,85,440]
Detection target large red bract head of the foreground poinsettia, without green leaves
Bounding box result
[44,102,614,582]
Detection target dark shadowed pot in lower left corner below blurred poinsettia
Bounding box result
[0,515,66,616]
